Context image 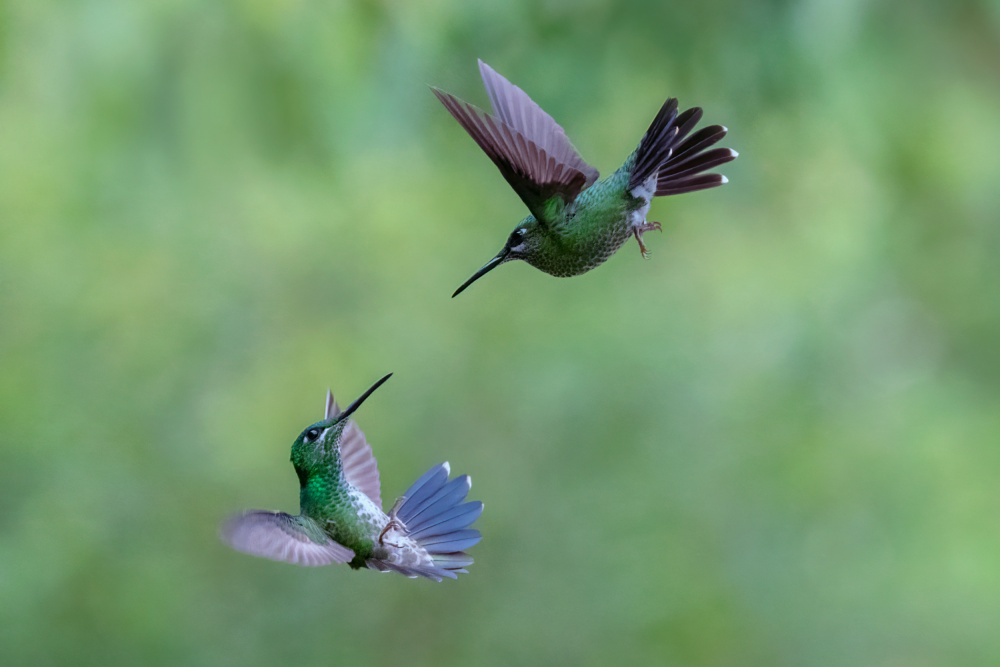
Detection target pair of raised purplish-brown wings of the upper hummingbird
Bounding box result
[432,60,599,222]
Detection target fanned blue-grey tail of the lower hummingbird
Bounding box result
[396,463,483,581]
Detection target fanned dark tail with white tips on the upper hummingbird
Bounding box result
[629,98,737,197]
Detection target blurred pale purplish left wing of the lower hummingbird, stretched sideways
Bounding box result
[221,510,354,566]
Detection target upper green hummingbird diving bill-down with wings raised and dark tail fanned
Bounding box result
[432,60,737,297]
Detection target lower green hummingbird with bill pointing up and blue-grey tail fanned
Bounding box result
[222,373,483,581]
